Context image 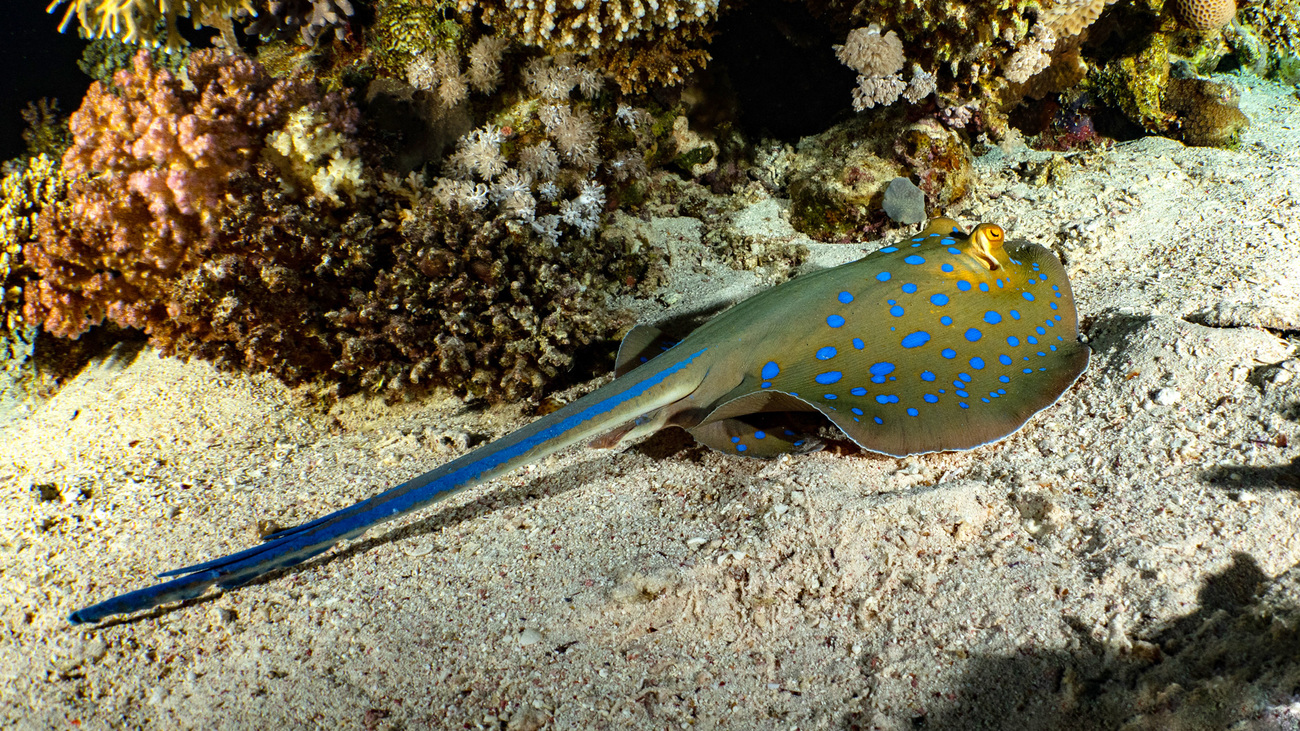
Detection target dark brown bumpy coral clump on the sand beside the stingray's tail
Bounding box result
[160,164,645,401]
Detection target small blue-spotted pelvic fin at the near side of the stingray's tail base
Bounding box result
[686,392,826,458]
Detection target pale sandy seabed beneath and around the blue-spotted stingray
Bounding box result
[0,77,1300,730]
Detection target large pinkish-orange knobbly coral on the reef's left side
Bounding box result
[26,51,356,337]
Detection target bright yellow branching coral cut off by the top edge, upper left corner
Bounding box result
[46,0,256,48]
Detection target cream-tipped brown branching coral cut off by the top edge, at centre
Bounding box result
[458,0,720,92]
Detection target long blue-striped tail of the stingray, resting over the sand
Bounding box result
[68,350,705,624]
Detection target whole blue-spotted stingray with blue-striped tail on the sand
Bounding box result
[69,219,1088,623]
